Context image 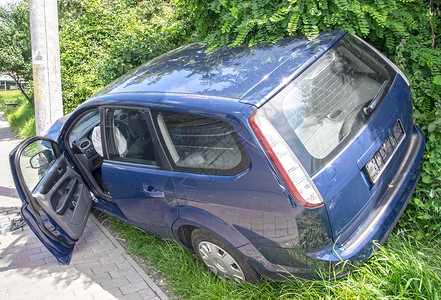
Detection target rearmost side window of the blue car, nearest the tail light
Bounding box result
[154,111,249,175]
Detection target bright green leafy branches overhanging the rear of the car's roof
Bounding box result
[186,0,402,47]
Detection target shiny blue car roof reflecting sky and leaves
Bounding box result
[96,31,346,105]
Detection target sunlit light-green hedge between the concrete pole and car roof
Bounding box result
[60,0,198,112]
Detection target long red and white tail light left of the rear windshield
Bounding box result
[249,110,323,208]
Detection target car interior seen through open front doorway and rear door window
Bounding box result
[68,109,156,194]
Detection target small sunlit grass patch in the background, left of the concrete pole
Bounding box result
[0,91,35,139]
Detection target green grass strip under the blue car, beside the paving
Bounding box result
[110,218,441,299]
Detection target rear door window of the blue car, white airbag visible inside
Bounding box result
[105,108,156,165]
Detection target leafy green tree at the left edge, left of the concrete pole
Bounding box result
[0,0,33,105]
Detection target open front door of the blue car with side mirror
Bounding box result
[9,137,92,264]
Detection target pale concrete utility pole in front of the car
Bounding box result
[29,0,63,135]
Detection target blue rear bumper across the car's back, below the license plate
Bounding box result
[308,125,425,262]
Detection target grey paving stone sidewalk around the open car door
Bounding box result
[0,112,167,300]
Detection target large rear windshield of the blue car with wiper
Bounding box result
[263,35,393,175]
